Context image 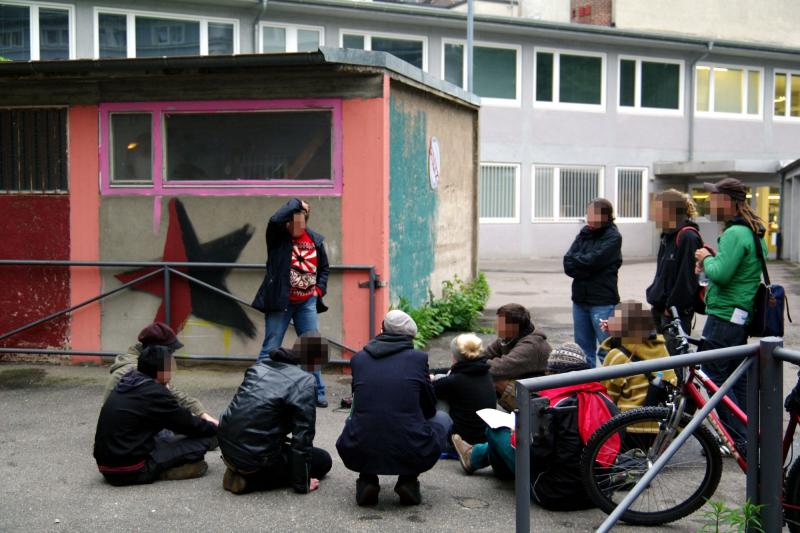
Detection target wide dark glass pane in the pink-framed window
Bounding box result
[164,111,333,181]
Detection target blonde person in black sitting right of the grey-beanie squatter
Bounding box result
[433,333,497,444]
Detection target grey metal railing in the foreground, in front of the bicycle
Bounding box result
[515,337,800,533]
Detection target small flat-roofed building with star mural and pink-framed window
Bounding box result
[0,48,478,355]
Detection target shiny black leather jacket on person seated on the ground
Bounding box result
[219,348,317,493]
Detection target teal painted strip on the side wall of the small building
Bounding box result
[389,95,439,306]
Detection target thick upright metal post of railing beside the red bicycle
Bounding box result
[760,337,783,531]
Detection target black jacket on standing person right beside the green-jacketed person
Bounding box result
[647,221,703,313]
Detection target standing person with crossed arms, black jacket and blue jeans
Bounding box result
[564,198,622,368]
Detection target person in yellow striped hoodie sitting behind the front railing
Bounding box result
[603,300,678,412]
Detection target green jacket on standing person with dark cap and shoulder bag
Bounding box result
[703,217,767,323]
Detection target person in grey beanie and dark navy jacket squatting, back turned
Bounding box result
[336,310,453,506]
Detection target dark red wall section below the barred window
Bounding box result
[0,194,70,347]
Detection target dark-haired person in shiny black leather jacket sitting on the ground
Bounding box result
[219,331,332,494]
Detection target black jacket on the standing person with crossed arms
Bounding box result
[564,222,622,305]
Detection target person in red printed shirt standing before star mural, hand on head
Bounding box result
[252,198,330,407]
